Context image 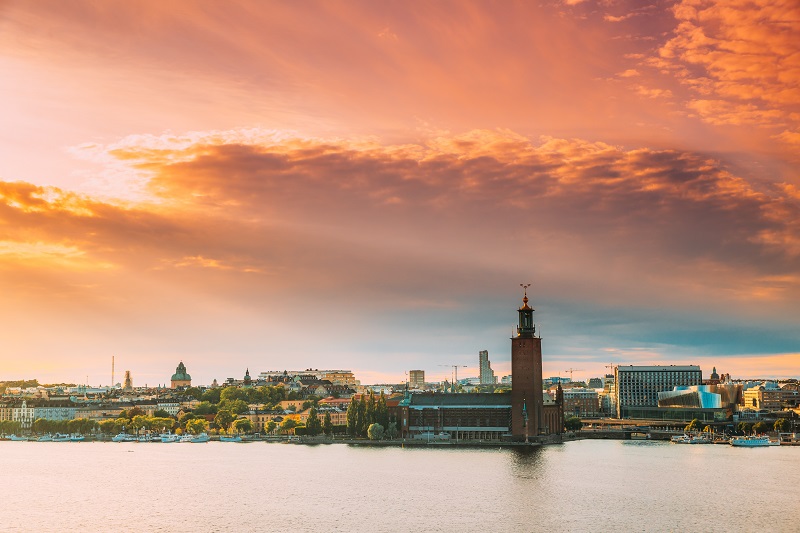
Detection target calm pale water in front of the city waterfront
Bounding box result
[0,440,800,532]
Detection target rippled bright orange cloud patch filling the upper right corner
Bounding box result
[651,0,800,133]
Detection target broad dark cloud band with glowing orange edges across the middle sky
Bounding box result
[0,130,800,380]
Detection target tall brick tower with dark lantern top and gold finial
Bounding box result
[511,285,543,439]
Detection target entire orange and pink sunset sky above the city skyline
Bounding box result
[0,0,800,386]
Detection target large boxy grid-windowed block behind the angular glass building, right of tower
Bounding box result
[614,365,703,418]
